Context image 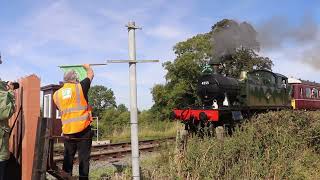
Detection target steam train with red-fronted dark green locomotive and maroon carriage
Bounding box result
[173,60,320,132]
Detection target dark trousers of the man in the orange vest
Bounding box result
[63,126,92,179]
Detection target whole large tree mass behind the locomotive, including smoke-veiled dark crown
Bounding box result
[151,19,272,119]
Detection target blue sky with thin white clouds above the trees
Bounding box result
[0,0,320,110]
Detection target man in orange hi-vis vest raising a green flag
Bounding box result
[53,64,94,179]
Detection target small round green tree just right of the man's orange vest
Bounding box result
[88,85,116,118]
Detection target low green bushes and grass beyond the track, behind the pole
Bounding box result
[93,107,181,142]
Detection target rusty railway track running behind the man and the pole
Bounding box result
[53,137,175,163]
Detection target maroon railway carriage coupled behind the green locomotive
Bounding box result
[289,78,320,110]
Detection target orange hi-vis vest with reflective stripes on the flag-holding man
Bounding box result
[53,83,92,134]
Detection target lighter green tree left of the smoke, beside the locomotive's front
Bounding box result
[151,33,212,119]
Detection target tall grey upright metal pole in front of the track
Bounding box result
[127,22,140,180]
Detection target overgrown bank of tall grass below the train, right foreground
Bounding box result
[138,111,320,179]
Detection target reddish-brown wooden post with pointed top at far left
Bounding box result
[9,75,40,180]
